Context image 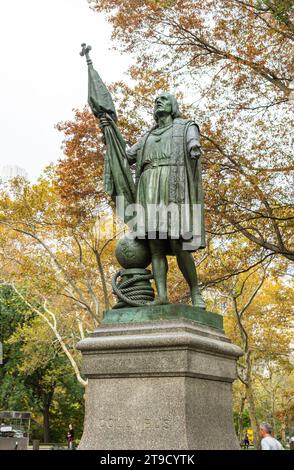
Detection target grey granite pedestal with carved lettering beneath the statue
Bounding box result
[78,306,242,450]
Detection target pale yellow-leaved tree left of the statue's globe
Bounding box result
[0,176,119,386]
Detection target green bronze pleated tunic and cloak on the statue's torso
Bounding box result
[127,118,205,251]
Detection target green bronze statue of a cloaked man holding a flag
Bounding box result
[81,44,205,309]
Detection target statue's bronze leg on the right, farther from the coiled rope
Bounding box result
[170,240,205,309]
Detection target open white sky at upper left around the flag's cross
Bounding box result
[0,0,130,179]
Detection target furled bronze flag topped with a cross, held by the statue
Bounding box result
[80,43,135,211]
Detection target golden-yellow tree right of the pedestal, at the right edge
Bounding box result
[219,264,293,448]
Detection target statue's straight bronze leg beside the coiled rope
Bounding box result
[148,240,168,305]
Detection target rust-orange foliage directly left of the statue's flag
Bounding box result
[52,108,107,215]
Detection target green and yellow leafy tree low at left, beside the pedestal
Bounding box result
[0,286,83,442]
